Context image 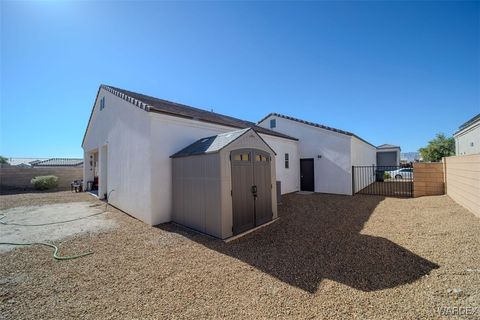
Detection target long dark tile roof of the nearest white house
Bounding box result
[82,85,298,145]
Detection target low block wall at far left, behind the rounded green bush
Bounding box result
[0,166,83,191]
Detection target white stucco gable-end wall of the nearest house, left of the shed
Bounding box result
[83,89,153,224]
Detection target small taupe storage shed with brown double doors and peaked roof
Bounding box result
[171,128,277,239]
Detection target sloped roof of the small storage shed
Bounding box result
[170,128,250,158]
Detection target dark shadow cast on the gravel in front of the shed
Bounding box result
[158,194,439,293]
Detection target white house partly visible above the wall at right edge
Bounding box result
[453,114,480,156]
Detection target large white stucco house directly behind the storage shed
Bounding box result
[82,85,299,232]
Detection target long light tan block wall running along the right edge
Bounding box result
[443,154,480,217]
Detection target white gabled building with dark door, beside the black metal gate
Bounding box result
[258,113,377,195]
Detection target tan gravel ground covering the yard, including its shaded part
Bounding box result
[0,194,480,319]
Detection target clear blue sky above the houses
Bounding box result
[0,1,480,157]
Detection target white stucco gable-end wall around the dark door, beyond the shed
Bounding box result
[259,116,352,195]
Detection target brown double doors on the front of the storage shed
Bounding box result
[230,149,272,235]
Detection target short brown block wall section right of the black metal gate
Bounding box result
[413,162,445,198]
